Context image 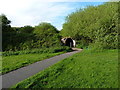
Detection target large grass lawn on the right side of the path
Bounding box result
[12,50,118,88]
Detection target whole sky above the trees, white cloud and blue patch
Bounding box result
[0,0,108,30]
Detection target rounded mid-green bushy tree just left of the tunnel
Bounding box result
[34,22,60,47]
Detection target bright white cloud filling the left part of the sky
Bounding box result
[0,0,75,29]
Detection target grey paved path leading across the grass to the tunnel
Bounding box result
[2,50,81,88]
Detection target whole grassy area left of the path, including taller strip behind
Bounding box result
[1,47,71,74]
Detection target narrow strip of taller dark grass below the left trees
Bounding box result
[2,46,72,56]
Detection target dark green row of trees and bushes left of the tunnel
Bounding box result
[0,15,61,51]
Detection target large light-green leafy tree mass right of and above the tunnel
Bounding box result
[61,2,119,49]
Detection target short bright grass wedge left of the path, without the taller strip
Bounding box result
[1,52,64,74]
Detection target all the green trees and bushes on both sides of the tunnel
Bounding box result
[0,2,120,51]
